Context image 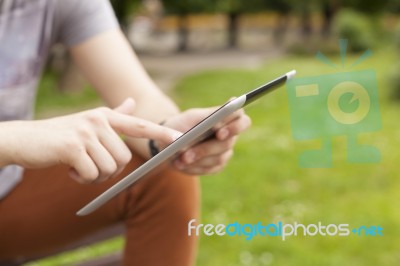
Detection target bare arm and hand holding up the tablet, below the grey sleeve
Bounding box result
[71,30,250,175]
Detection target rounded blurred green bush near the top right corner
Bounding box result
[333,9,375,52]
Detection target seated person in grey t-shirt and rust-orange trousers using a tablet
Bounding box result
[0,0,250,266]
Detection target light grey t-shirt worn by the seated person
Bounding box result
[0,0,118,199]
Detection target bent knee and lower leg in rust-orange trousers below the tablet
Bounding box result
[124,162,200,266]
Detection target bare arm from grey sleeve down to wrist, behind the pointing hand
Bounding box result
[71,30,179,158]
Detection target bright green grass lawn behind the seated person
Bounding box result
[29,48,400,266]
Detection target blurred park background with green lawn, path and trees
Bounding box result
[30,0,400,266]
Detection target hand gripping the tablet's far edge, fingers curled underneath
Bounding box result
[164,108,251,175]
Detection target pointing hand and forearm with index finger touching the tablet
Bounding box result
[0,99,180,183]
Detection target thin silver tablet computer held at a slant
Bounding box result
[76,70,296,216]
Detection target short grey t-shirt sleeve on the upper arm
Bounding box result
[54,0,119,47]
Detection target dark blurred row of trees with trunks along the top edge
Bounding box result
[106,0,400,51]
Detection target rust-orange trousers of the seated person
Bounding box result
[0,158,200,266]
